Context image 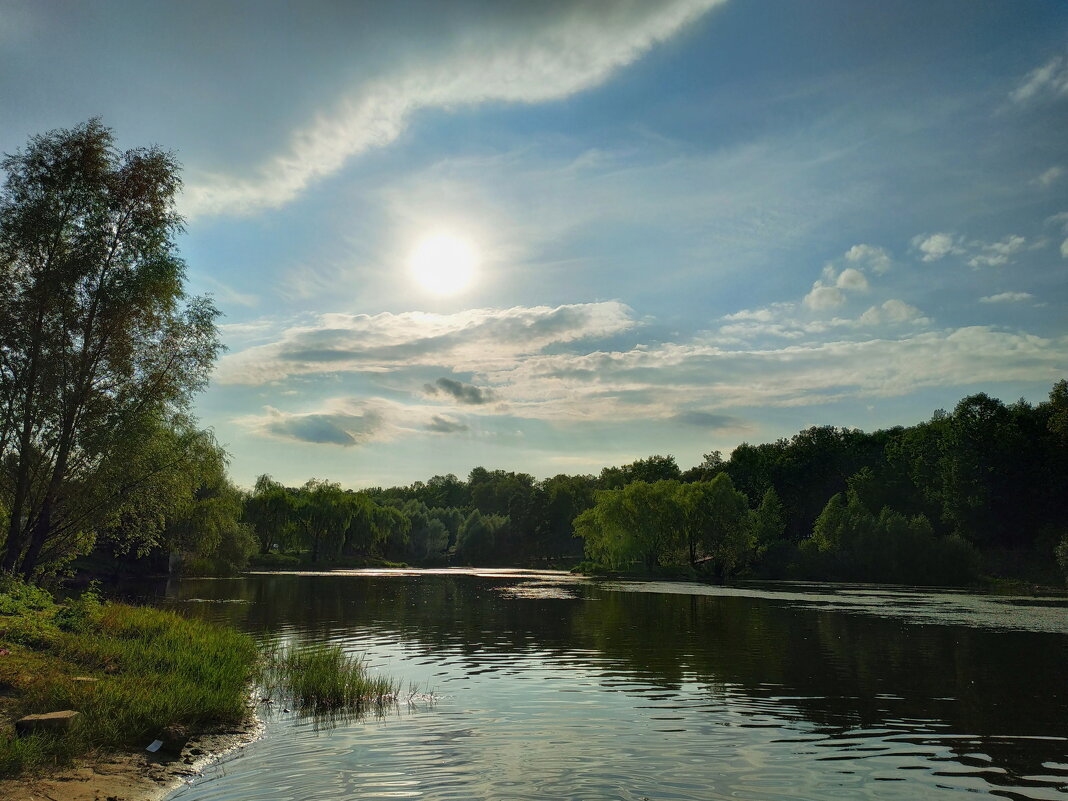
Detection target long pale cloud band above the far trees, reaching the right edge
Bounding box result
[510,326,1068,420]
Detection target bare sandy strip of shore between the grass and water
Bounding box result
[0,712,263,801]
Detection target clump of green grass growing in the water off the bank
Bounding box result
[260,645,401,712]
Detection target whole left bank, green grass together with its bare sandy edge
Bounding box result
[0,581,257,801]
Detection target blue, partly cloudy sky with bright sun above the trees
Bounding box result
[0,0,1068,487]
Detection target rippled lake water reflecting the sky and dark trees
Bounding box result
[144,571,1068,801]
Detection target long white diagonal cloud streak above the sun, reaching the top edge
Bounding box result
[182,0,723,217]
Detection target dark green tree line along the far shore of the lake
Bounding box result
[246,381,1068,584]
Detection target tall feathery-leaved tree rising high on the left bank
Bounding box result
[0,120,219,576]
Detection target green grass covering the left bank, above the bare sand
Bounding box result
[0,580,257,776]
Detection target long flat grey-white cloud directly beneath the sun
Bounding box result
[215,301,637,389]
